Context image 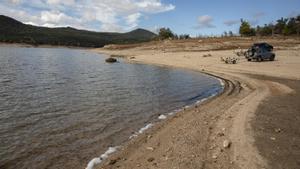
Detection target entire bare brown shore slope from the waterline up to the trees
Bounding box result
[95,38,300,169]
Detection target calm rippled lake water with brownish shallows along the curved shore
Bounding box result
[0,47,222,169]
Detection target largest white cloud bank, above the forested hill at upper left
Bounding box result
[0,0,175,32]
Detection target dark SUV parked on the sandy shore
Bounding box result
[245,43,275,62]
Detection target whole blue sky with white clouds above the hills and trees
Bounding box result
[0,0,300,36]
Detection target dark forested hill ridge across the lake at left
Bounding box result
[0,15,157,47]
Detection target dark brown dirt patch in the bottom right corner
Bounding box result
[251,76,300,169]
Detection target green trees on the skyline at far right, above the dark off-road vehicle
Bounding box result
[240,15,300,36]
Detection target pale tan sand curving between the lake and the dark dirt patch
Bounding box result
[93,40,300,169]
